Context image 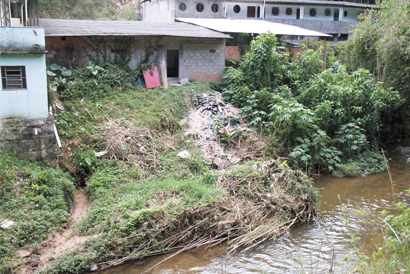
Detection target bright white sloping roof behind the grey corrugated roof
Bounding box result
[177,18,331,37]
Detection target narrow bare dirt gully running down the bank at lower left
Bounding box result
[19,189,90,274]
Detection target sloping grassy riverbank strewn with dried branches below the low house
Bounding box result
[1,84,317,273]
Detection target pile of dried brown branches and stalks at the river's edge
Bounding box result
[97,160,316,269]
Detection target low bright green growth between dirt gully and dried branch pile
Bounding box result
[78,174,223,235]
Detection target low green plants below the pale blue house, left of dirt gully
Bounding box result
[0,154,74,273]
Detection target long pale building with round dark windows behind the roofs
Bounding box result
[144,0,377,41]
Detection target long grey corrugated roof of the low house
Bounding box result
[40,19,230,38]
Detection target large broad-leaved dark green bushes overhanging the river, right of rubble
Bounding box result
[223,34,403,171]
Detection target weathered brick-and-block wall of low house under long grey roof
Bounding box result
[46,36,225,81]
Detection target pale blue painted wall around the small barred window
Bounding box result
[0,55,48,119]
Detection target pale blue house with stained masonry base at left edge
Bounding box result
[0,27,57,165]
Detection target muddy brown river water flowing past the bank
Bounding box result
[99,140,410,274]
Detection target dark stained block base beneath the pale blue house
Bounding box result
[0,118,57,166]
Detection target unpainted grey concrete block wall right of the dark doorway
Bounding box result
[180,39,225,82]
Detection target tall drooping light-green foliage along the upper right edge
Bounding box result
[340,0,410,140]
